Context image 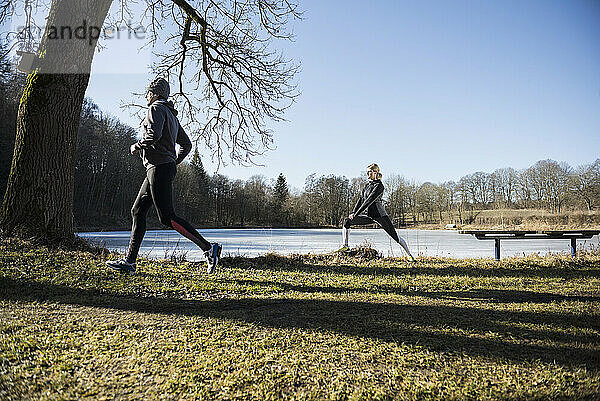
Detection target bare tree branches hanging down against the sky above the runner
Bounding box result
[135,0,301,165]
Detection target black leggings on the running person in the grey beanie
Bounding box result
[127,163,210,263]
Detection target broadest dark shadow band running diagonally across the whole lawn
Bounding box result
[0,277,600,370]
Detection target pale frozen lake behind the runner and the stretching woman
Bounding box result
[78,228,599,261]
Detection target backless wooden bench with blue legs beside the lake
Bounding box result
[458,230,600,260]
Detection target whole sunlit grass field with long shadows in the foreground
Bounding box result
[0,236,600,400]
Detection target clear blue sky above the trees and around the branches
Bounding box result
[81,0,600,188]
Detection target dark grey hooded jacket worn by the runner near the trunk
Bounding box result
[135,98,192,169]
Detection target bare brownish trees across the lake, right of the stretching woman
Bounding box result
[385,159,600,225]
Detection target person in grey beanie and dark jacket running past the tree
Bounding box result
[106,78,222,274]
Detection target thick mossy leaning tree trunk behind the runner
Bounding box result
[0,0,112,239]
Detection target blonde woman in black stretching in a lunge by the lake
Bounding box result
[341,163,415,260]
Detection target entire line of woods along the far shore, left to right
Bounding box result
[0,51,600,230]
